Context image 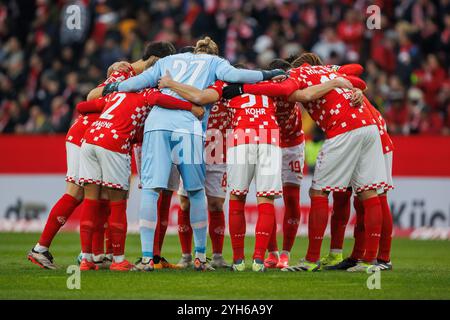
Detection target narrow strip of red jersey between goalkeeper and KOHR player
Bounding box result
[205,99,231,164]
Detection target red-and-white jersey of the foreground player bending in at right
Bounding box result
[290,64,374,138]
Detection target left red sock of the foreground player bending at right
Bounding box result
[306,196,328,262]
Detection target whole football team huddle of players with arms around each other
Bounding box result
[28,37,393,272]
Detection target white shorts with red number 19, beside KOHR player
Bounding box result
[281,142,305,185]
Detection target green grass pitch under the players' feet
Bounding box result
[0,233,450,299]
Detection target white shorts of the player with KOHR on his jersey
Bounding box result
[227,144,282,198]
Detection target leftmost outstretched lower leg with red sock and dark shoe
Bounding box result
[27,182,83,269]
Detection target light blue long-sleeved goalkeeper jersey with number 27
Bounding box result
[118,52,263,135]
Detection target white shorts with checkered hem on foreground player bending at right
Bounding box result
[312,125,387,193]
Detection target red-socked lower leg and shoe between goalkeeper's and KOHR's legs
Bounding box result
[206,196,229,268]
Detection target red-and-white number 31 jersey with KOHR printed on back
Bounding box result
[210,81,280,147]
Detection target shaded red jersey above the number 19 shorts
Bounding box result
[274,97,305,148]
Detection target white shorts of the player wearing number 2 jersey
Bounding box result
[80,142,131,190]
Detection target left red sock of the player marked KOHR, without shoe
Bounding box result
[228,200,246,261]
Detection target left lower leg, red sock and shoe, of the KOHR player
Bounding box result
[228,194,246,271]
